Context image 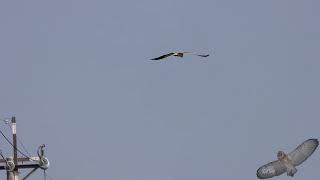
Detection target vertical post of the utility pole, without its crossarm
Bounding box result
[11,116,19,180]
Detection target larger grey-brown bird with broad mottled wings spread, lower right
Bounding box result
[257,139,319,179]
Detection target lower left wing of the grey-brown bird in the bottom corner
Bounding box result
[257,160,287,179]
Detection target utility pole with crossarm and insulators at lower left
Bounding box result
[0,117,50,180]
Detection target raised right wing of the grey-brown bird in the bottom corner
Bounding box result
[289,139,319,166]
